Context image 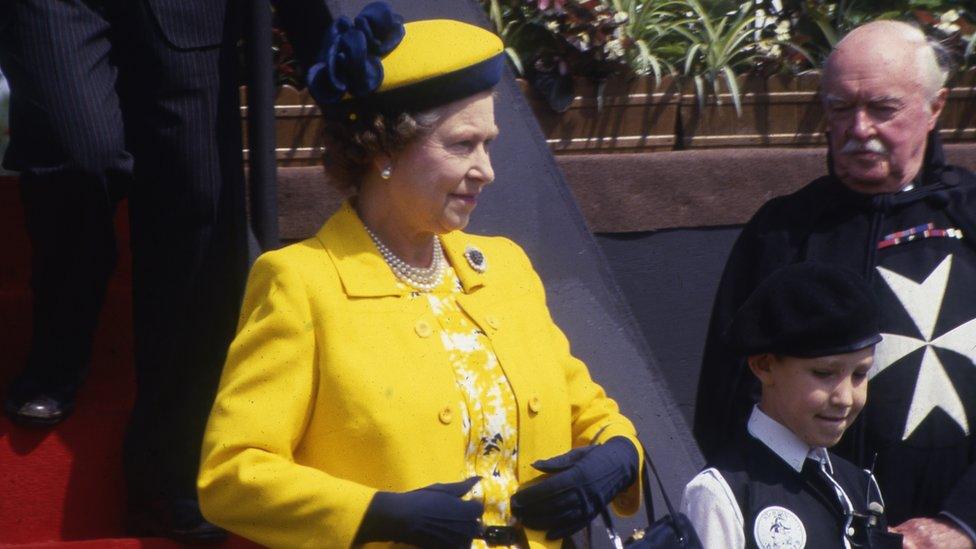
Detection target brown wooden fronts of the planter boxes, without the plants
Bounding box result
[241,69,976,167]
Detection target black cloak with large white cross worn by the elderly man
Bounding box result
[694,132,976,530]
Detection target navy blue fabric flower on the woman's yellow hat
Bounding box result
[307,2,404,104]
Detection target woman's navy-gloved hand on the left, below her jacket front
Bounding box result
[355,477,484,549]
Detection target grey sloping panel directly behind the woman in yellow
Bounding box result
[326,0,704,537]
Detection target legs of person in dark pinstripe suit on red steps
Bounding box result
[0,0,328,540]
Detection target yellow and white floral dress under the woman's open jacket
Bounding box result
[411,265,518,549]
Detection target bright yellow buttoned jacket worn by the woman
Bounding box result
[198,204,640,547]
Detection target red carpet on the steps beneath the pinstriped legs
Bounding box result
[0,177,252,549]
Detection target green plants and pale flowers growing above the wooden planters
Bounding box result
[482,0,976,113]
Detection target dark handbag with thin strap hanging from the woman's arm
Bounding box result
[600,445,703,549]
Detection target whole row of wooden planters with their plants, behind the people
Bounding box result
[254,0,976,165]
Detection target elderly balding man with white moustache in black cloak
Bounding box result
[695,21,976,547]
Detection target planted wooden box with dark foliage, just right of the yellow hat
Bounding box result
[483,0,680,153]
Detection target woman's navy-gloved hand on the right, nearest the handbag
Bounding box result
[512,437,640,540]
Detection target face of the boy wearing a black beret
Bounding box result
[749,345,874,448]
